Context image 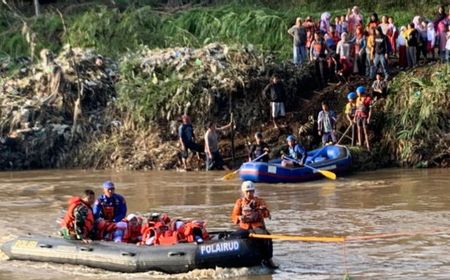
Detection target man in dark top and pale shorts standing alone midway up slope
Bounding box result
[263,74,286,128]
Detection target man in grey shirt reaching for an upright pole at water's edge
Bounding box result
[205,121,232,171]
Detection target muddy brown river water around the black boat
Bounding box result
[0,169,450,280]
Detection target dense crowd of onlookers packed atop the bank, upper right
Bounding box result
[288,6,450,84]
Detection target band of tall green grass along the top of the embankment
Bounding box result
[0,1,435,59]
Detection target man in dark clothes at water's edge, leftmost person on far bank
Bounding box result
[178,114,202,170]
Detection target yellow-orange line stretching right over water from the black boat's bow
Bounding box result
[249,228,450,243]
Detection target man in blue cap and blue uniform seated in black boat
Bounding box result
[94,181,127,223]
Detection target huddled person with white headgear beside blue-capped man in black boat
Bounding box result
[113,214,142,243]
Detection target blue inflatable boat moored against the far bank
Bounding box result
[239,145,352,183]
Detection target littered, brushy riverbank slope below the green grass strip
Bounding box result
[0,2,450,170]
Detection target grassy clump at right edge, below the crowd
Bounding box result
[382,64,450,166]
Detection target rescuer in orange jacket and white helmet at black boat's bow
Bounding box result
[231,181,276,268]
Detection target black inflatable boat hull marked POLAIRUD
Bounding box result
[1,232,272,273]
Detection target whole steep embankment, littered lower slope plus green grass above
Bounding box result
[0,3,450,169]
